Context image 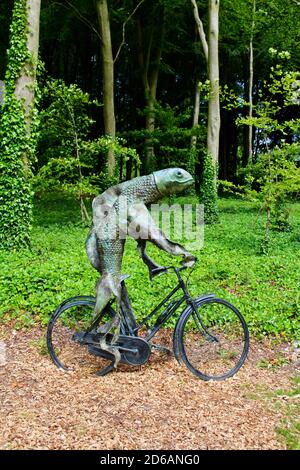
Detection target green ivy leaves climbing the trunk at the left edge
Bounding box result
[0,0,38,248]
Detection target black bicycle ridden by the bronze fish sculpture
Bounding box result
[47,266,249,380]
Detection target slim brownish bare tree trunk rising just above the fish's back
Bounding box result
[96,0,116,176]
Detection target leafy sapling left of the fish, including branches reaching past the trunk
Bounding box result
[34,79,139,200]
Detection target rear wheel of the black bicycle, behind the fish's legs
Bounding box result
[47,296,115,373]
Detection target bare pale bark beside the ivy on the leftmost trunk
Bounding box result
[14,0,41,172]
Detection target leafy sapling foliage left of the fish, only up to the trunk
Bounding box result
[34,79,98,198]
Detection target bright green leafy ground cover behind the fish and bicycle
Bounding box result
[0,193,300,339]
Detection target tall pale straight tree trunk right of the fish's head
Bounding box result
[207,0,221,168]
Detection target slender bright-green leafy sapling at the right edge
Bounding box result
[234,56,300,237]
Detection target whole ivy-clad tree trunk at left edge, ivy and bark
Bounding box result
[0,0,41,247]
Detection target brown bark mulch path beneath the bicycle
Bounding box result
[0,325,299,450]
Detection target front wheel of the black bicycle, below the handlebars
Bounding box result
[174,297,249,380]
